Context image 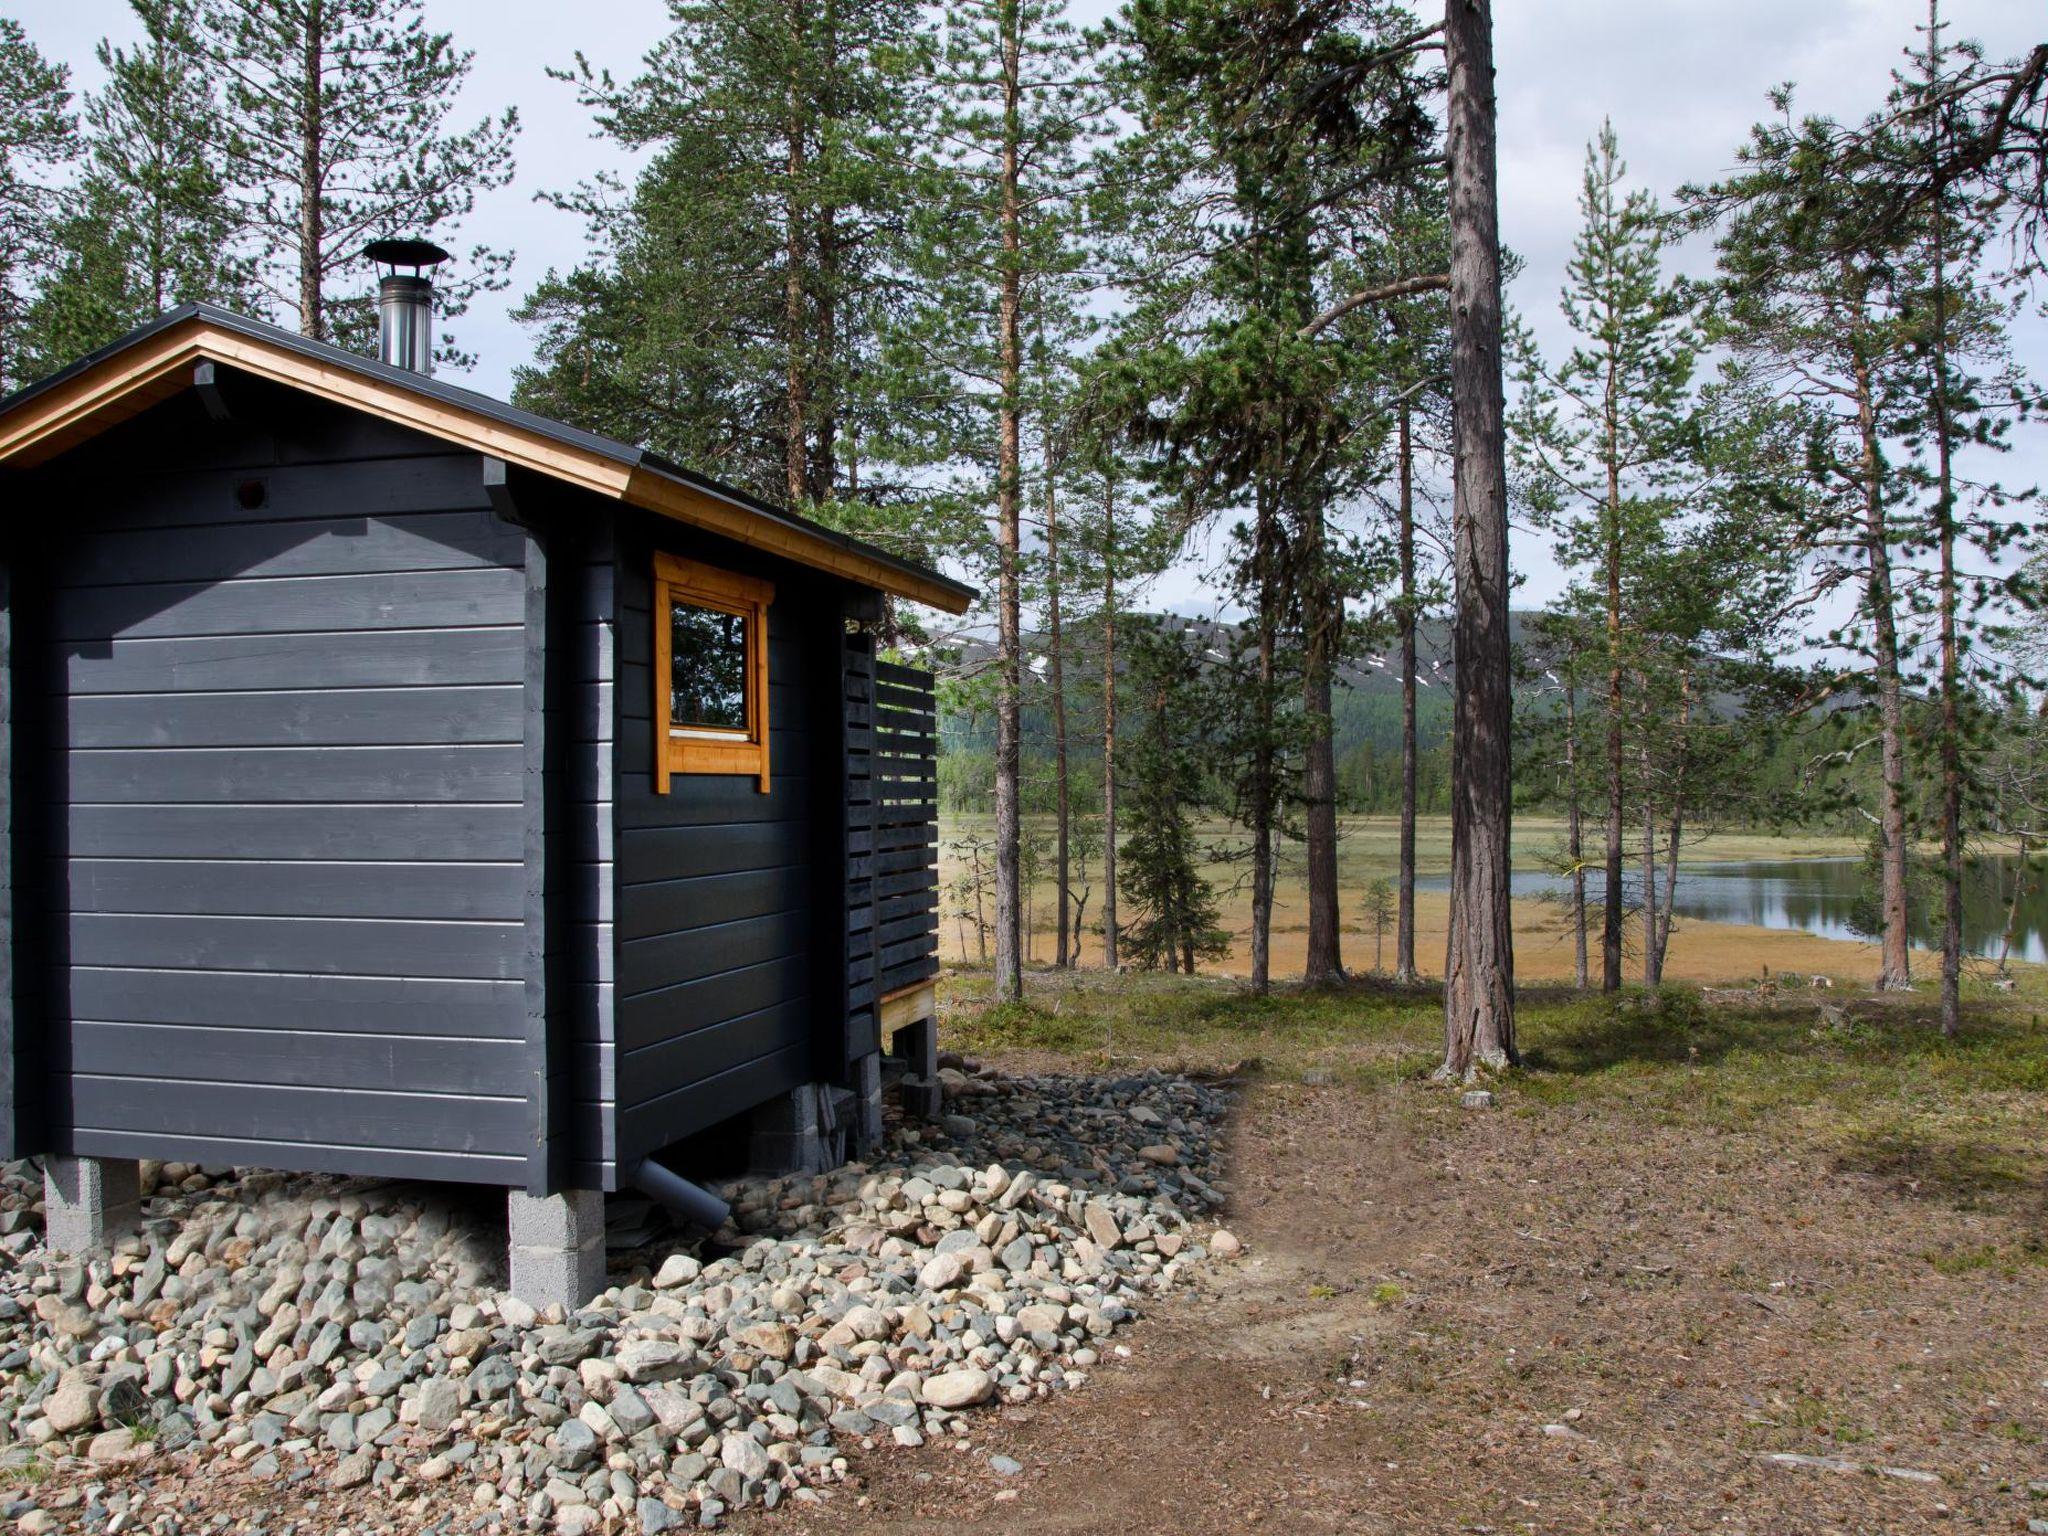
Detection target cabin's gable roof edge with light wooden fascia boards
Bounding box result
[0,303,975,612]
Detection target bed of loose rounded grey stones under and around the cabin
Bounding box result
[0,1071,1237,1536]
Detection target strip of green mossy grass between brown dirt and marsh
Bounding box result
[944,971,2048,1220]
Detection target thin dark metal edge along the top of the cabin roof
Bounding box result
[0,303,979,602]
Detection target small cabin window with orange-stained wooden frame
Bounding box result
[653,555,774,795]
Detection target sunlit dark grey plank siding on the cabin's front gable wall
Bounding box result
[37,397,536,1184]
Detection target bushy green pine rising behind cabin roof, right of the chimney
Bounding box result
[516,0,937,544]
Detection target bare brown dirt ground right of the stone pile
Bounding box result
[743,1083,2048,1536]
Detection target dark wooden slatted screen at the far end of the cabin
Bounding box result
[844,635,938,1057]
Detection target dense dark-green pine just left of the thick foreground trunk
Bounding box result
[1112,0,1446,987]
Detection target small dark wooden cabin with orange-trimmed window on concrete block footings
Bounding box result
[0,307,973,1294]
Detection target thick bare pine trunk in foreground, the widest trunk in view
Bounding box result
[1440,0,1520,1079]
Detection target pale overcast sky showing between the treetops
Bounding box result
[19,0,2048,606]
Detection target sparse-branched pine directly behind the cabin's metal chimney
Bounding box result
[190,0,518,348]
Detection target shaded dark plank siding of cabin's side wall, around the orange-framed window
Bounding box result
[606,514,840,1167]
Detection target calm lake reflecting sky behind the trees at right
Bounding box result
[1417,856,2048,963]
